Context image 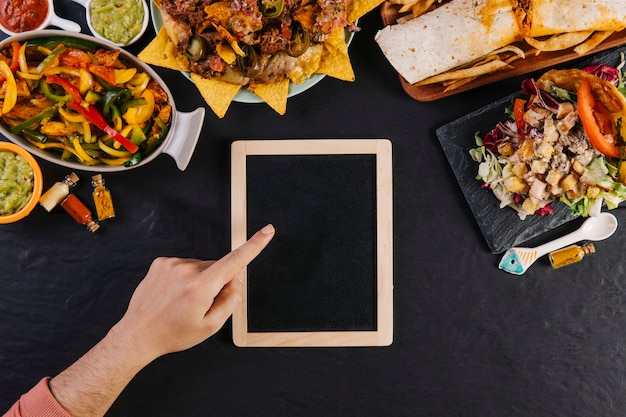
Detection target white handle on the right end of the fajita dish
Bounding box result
[162,107,204,171]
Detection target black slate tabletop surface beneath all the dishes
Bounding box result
[0,0,626,417]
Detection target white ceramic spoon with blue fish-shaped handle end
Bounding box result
[498,212,617,275]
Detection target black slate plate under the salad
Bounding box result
[436,48,626,254]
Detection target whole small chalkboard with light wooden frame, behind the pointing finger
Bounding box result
[231,139,393,347]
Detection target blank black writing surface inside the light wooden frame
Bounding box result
[247,155,376,332]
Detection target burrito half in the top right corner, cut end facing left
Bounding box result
[510,0,626,38]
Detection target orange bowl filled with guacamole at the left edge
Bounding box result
[0,142,43,224]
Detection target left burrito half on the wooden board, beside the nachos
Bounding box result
[375,0,520,84]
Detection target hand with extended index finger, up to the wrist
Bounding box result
[110,225,274,363]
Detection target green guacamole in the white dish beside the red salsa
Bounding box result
[89,0,144,45]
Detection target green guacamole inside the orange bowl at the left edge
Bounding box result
[0,151,34,215]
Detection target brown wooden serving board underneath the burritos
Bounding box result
[380,1,626,101]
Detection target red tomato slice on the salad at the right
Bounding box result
[578,78,620,158]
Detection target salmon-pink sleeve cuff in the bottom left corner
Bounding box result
[3,378,72,417]
